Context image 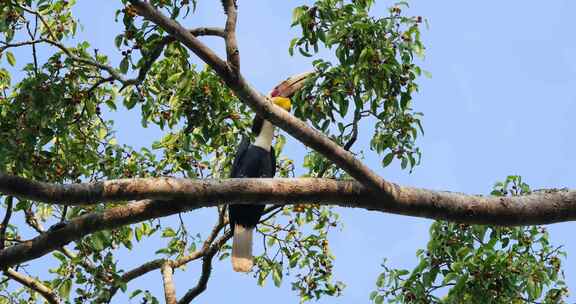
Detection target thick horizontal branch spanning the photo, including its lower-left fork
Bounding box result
[0,174,576,267]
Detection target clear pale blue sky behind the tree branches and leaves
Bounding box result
[2,0,576,304]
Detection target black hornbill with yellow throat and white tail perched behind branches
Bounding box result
[228,73,311,272]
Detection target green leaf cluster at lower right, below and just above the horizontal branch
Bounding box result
[370,176,568,304]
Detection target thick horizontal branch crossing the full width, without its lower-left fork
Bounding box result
[0,173,576,225]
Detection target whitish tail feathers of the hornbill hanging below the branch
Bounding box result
[232,224,254,272]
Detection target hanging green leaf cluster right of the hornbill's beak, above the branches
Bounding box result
[290,0,424,173]
